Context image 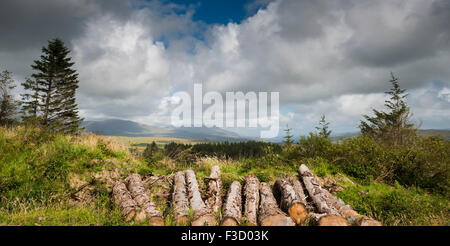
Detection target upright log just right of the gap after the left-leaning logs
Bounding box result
[172,171,189,225]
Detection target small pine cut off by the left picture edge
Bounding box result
[0,70,18,125]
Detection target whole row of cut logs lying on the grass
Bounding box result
[112,165,381,226]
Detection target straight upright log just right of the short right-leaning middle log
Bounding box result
[244,175,259,225]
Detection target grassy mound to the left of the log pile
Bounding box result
[0,127,143,225]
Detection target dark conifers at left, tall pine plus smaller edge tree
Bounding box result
[0,38,83,134]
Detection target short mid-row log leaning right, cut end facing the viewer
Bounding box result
[222,181,242,226]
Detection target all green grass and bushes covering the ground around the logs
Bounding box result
[0,127,450,225]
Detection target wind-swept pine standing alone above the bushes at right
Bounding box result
[359,73,417,145]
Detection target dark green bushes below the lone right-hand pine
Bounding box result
[292,133,450,196]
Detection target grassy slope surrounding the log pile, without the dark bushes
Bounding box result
[0,128,450,225]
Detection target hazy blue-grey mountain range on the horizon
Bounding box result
[81,119,250,142]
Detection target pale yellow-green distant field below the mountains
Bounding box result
[110,136,201,151]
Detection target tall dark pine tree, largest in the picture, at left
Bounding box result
[31,39,82,133]
